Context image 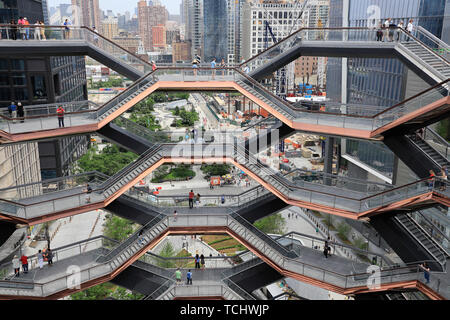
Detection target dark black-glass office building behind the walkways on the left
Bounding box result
[0,0,89,181]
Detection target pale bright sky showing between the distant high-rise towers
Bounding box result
[47,0,181,14]
